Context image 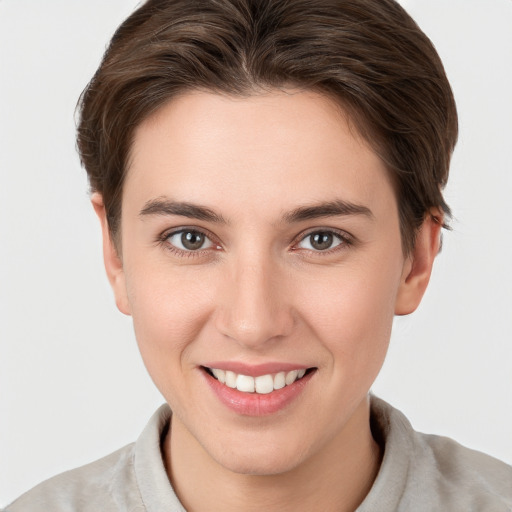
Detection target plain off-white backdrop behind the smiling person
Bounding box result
[0,0,512,505]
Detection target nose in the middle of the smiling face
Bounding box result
[216,257,294,350]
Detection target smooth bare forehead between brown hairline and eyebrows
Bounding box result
[124,91,394,220]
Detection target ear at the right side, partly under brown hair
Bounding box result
[395,209,443,315]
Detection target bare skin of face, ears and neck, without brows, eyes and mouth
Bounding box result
[93,90,440,512]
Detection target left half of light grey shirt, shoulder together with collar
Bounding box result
[4,404,176,512]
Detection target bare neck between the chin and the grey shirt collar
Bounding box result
[164,399,381,512]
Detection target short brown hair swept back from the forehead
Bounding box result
[77,0,457,252]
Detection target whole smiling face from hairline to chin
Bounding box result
[97,91,436,474]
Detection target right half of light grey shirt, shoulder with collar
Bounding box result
[362,396,512,512]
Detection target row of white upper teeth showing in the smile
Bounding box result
[210,368,306,394]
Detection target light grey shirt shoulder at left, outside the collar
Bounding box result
[5,444,144,512]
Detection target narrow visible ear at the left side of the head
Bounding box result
[91,192,130,315]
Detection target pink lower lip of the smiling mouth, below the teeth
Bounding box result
[201,370,316,416]
